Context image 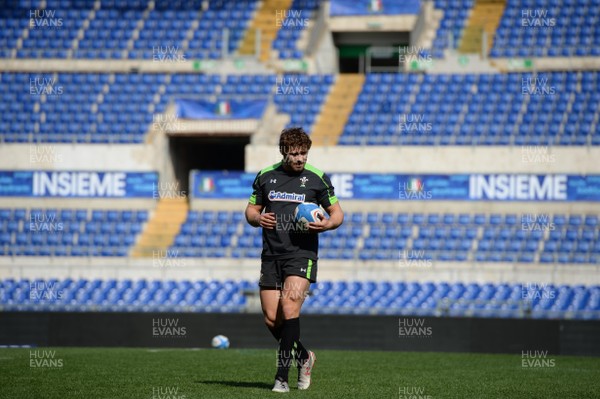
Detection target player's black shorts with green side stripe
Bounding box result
[258,258,317,289]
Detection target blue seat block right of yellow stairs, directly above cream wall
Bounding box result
[339,72,600,145]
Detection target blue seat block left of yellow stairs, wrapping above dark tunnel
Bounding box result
[0,73,333,144]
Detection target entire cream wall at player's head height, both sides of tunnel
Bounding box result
[0,145,600,174]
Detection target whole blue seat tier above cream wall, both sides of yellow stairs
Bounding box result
[0,72,600,145]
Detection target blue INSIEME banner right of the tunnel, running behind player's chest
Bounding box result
[191,171,600,202]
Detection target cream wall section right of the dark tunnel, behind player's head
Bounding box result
[246,145,600,174]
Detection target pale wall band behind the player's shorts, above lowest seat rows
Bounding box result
[0,256,600,287]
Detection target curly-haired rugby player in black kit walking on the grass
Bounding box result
[245,127,344,392]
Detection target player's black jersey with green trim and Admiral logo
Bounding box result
[248,162,337,260]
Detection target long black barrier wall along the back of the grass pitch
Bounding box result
[0,312,600,356]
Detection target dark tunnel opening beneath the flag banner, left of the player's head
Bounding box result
[169,136,250,195]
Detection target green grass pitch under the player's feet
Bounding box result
[0,348,600,399]
